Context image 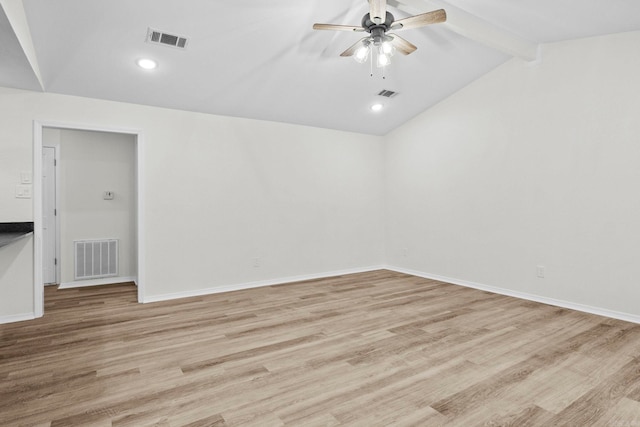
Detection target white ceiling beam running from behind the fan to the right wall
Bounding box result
[396,0,540,62]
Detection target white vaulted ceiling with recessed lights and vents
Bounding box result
[0,0,640,135]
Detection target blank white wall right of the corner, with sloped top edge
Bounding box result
[386,32,640,316]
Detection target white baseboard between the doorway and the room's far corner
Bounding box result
[142,265,384,303]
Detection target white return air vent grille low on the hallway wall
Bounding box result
[73,239,118,280]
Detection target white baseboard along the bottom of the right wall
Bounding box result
[384,266,640,323]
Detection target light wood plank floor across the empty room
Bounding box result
[0,271,640,427]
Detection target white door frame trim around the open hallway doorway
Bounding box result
[33,120,146,317]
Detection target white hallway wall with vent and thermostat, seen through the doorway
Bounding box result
[42,128,137,285]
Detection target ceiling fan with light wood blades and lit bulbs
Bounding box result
[313,0,447,67]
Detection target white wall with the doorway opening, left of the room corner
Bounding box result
[0,88,384,316]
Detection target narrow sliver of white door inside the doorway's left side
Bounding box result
[42,147,58,284]
